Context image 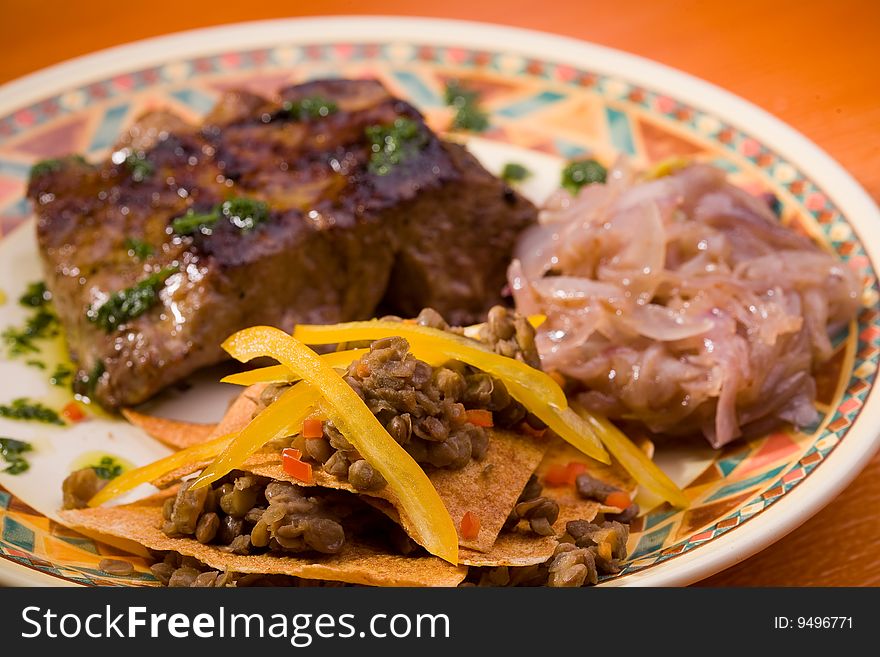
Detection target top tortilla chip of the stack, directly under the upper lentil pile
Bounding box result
[241,429,549,552]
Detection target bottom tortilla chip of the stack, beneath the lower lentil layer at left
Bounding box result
[60,491,467,586]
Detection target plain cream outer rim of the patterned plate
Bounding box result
[0,16,880,586]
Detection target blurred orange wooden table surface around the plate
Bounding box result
[0,0,880,586]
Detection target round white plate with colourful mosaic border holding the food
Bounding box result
[0,17,880,586]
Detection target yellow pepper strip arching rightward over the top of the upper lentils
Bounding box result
[293,320,568,409]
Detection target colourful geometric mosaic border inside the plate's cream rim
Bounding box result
[0,43,880,585]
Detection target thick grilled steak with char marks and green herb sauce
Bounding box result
[28,80,537,408]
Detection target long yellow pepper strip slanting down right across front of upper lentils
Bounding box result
[211,325,458,564]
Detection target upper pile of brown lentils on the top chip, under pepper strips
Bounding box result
[261,306,544,491]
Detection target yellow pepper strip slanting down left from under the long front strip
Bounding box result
[190,380,322,490]
